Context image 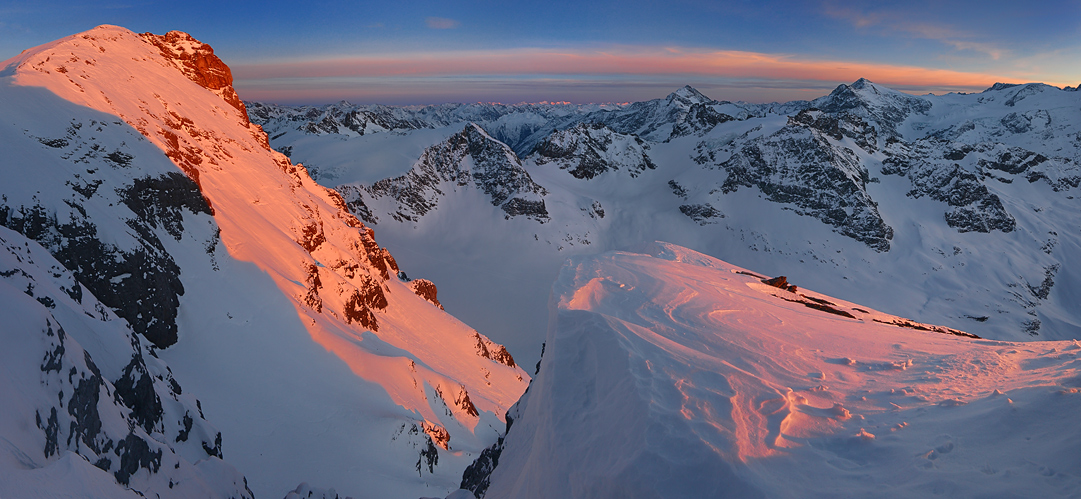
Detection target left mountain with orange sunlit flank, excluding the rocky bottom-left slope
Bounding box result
[0,26,529,496]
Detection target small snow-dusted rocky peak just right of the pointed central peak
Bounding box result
[533,123,657,179]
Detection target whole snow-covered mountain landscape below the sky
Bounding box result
[0,26,1081,499]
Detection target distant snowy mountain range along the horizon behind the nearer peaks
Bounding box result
[248,86,773,159]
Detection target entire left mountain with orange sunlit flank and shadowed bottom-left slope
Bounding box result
[0,26,529,497]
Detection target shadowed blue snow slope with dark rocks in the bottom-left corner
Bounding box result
[0,228,252,499]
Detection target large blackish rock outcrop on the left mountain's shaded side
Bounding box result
[0,150,210,348]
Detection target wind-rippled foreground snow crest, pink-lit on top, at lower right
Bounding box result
[486,243,1081,498]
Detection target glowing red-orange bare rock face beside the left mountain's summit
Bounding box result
[141,31,248,119]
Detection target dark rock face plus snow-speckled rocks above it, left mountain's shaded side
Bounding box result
[0,120,211,348]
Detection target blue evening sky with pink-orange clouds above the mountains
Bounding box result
[0,0,1081,105]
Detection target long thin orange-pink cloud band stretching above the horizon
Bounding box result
[232,46,1028,90]
